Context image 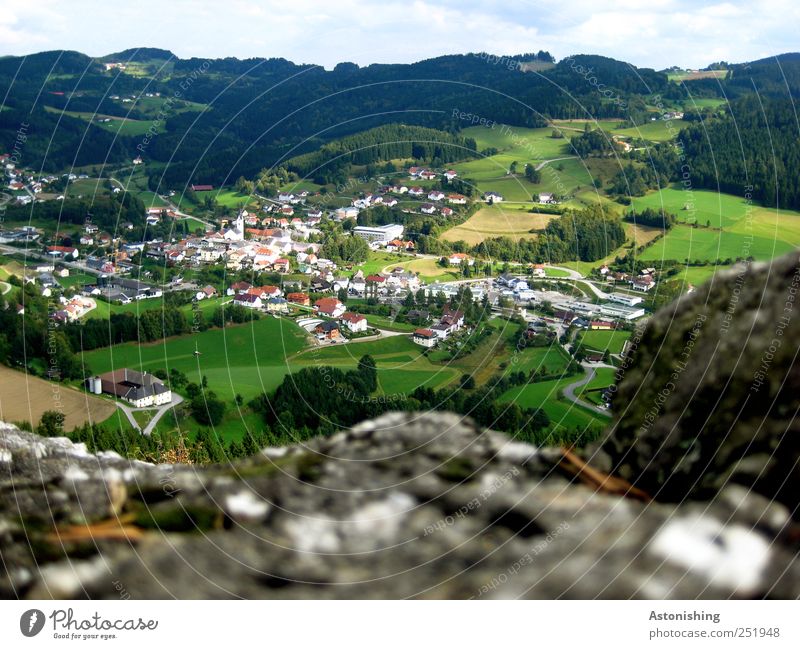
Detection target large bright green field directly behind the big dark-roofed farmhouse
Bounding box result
[83,318,306,401]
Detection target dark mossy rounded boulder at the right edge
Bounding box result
[598,253,800,515]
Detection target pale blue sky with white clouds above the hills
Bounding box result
[0,0,800,69]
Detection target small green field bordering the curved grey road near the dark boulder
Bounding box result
[500,376,606,431]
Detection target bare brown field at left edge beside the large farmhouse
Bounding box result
[0,365,116,431]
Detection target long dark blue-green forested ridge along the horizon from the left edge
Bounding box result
[0,50,683,184]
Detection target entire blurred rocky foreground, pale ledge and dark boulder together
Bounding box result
[0,255,800,599]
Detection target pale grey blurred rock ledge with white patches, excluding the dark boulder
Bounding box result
[0,413,800,599]
